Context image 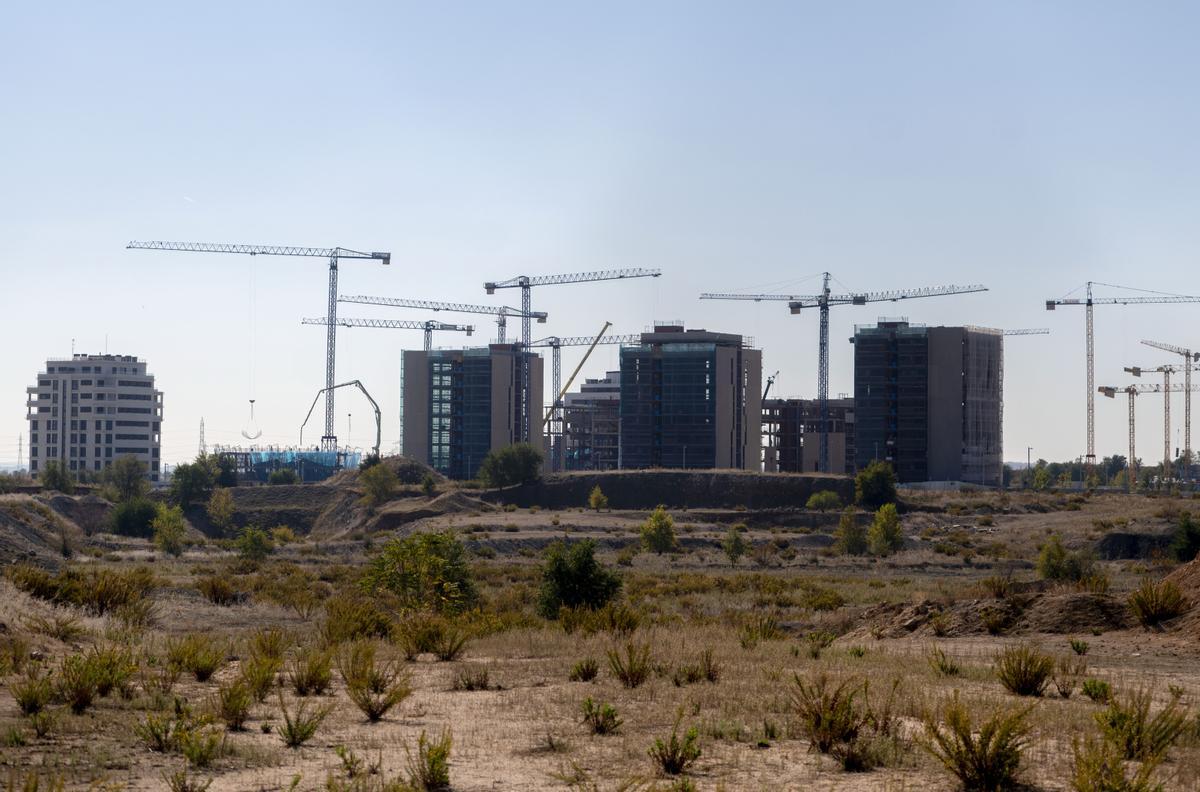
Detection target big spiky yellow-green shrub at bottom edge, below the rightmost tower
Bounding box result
[922,691,1030,792]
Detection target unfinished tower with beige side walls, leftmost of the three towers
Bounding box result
[401,343,542,479]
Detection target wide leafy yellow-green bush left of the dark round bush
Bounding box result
[361,530,479,613]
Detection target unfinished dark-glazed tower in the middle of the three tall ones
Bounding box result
[620,323,762,470]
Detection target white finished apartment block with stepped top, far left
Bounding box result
[25,354,162,481]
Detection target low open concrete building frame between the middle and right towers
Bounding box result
[762,397,854,475]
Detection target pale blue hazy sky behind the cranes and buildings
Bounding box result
[0,0,1200,466]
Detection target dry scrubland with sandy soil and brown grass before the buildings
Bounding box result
[0,475,1200,792]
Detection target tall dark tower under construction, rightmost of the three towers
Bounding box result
[853,319,1004,486]
